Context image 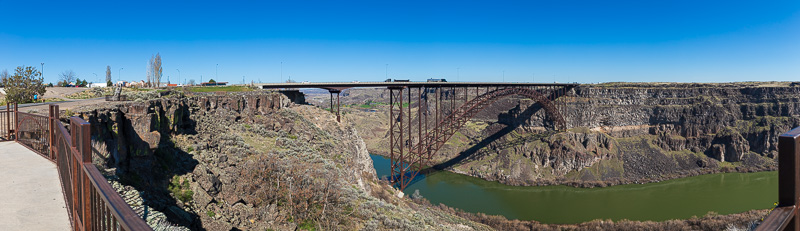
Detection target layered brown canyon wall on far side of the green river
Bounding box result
[340,82,800,186]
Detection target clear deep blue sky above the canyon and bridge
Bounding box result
[0,0,800,83]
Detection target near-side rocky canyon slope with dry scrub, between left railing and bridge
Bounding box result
[79,92,487,230]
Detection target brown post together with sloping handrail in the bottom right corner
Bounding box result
[756,127,800,231]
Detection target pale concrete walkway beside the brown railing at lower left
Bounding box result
[0,141,71,230]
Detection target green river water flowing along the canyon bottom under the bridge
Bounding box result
[370,155,778,224]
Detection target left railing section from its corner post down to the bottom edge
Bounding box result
[48,105,152,230]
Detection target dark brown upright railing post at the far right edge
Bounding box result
[778,128,800,230]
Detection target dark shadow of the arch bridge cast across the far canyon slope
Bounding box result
[397,99,552,188]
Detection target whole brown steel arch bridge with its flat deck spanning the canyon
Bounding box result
[258,82,578,190]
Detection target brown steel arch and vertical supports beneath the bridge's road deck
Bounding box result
[389,87,569,190]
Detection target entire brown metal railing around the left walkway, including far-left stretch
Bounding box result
[0,104,153,231]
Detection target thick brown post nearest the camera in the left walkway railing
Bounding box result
[78,120,92,230]
